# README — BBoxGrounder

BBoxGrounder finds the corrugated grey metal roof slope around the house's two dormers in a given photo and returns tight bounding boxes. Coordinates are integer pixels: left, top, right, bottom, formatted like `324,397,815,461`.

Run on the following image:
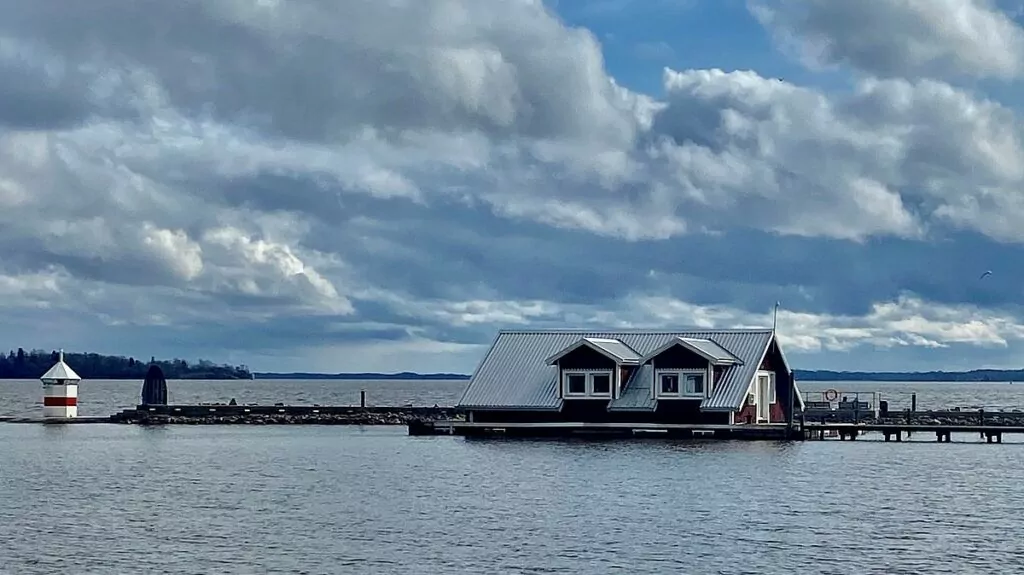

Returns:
459,329,771,409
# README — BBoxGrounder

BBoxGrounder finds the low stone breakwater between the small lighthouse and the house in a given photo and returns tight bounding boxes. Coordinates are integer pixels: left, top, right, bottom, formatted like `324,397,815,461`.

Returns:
111,405,462,426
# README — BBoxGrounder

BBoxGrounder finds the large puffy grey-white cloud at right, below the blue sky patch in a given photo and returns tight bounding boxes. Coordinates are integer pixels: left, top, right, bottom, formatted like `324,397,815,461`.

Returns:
655,70,1024,241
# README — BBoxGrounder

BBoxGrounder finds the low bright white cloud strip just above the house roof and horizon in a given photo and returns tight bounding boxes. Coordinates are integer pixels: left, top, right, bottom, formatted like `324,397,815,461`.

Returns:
342,293,1024,368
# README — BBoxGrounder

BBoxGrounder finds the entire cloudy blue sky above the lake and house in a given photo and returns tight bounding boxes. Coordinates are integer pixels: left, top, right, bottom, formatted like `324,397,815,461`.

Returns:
6,0,1024,371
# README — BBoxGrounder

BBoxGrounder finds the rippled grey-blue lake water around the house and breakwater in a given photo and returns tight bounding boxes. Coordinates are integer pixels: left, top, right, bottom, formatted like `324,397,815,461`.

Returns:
0,380,1024,575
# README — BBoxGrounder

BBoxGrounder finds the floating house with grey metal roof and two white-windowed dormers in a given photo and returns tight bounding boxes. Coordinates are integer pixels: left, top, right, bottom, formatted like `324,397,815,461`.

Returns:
458,329,803,426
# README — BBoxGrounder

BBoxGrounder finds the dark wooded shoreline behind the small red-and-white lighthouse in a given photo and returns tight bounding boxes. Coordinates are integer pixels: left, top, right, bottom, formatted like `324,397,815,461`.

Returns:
0,348,252,380
